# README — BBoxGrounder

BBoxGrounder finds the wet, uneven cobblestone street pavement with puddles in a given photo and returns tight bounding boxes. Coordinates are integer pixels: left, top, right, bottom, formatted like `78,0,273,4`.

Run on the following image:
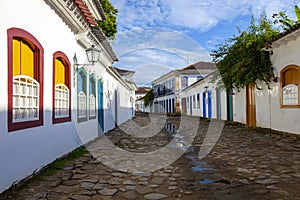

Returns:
0,114,300,200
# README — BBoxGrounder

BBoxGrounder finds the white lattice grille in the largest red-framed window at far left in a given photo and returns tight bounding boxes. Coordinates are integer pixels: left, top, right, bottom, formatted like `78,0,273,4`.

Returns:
12,75,40,122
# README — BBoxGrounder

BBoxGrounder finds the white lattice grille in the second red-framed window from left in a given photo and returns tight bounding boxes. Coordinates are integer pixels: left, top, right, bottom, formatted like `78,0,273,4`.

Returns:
54,84,69,118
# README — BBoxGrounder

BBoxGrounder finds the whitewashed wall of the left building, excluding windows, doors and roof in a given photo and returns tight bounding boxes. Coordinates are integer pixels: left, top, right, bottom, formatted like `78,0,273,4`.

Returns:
0,0,131,192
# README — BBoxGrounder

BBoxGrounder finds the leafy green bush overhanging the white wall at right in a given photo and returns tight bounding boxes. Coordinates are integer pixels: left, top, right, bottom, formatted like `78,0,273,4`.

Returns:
211,14,279,89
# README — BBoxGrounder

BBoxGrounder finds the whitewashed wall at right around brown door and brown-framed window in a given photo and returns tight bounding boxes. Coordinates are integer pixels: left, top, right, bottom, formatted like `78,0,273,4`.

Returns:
234,38,300,134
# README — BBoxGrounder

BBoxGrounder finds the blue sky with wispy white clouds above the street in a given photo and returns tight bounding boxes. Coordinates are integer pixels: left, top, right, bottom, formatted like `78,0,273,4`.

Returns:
110,0,299,85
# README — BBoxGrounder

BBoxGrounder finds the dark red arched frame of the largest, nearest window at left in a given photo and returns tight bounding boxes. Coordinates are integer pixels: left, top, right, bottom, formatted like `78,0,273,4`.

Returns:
7,28,44,131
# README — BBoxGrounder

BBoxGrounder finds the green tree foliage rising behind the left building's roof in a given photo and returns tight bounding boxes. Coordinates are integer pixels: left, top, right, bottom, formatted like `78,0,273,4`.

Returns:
98,0,118,39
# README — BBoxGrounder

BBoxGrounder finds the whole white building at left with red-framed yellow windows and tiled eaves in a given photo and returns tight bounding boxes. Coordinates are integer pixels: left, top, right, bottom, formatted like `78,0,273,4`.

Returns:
0,0,133,192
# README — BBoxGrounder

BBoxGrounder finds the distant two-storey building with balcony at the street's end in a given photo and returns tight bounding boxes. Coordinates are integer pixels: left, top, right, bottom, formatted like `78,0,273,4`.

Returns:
152,62,216,113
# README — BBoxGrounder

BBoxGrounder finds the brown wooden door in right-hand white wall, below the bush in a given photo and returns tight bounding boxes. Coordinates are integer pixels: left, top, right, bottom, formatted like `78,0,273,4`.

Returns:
246,84,256,126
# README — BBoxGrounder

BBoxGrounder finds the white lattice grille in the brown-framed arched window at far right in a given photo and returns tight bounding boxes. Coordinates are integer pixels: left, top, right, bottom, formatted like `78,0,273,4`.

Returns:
282,84,298,105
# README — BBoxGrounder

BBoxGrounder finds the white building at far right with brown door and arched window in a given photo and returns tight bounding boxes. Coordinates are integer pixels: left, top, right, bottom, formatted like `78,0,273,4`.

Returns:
234,25,300,134
